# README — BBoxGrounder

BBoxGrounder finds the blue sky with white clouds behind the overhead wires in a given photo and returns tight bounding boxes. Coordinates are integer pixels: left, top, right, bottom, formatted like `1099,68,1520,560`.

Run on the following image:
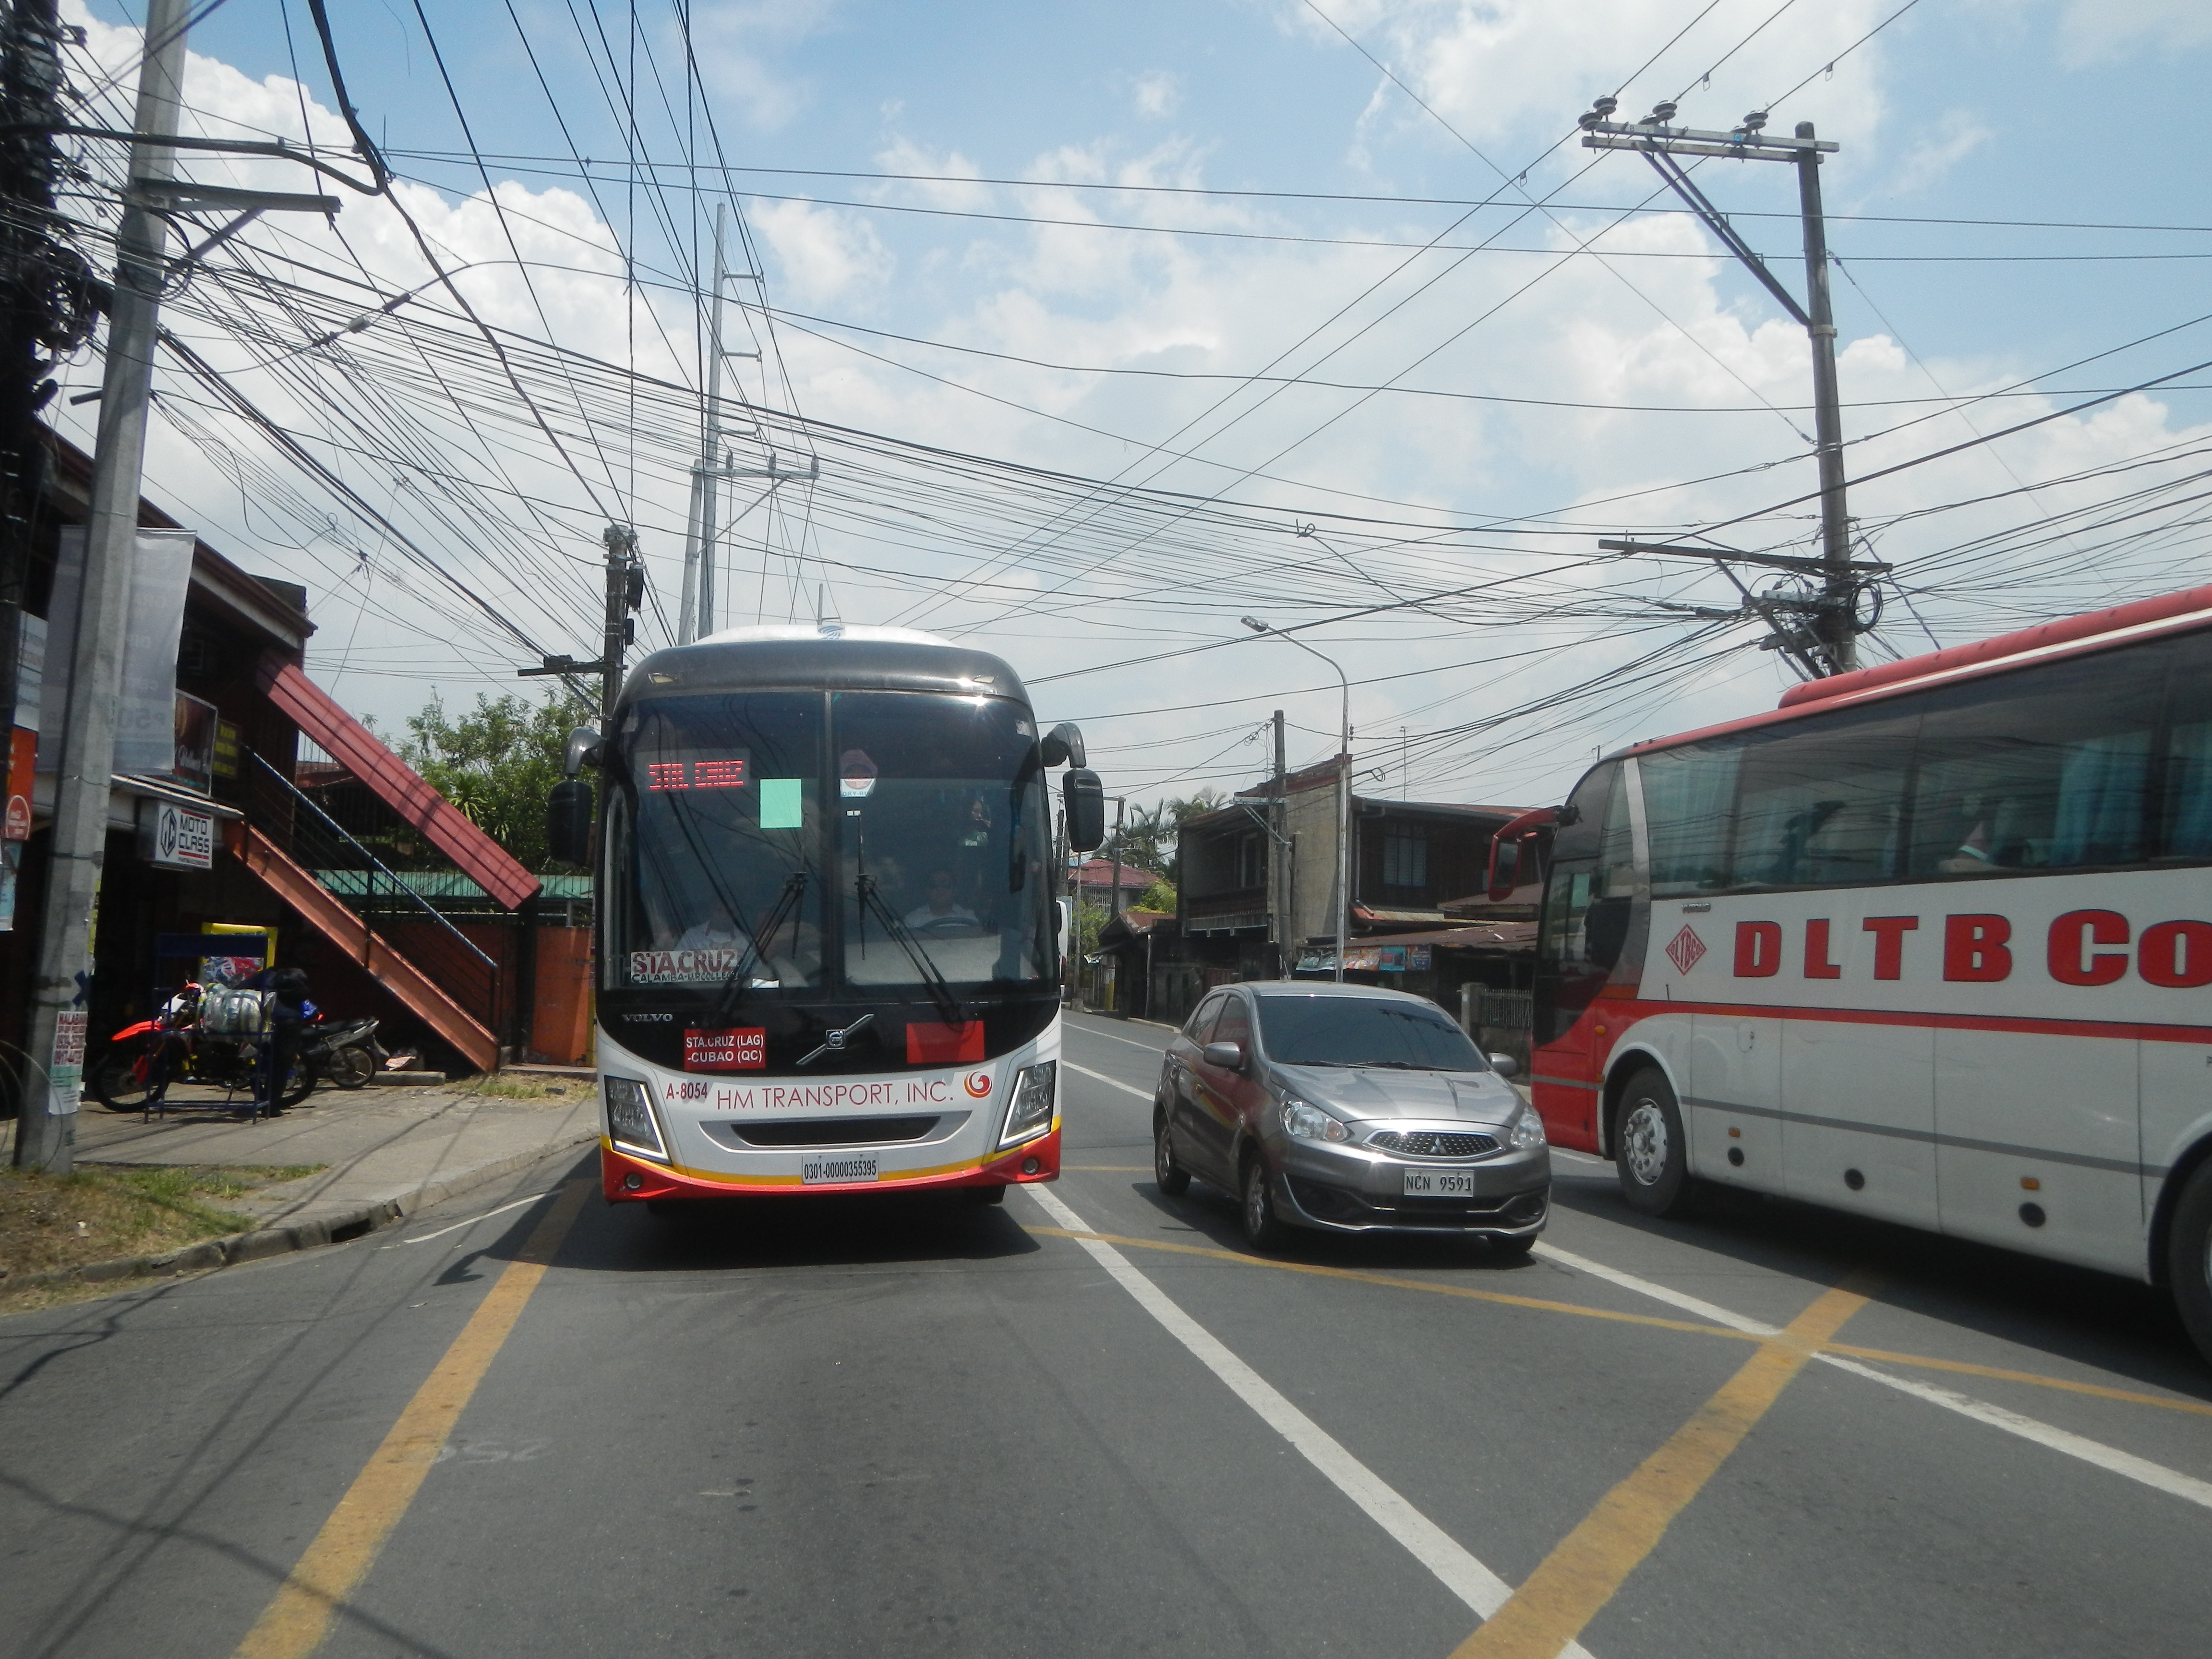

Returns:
60,0,2212,798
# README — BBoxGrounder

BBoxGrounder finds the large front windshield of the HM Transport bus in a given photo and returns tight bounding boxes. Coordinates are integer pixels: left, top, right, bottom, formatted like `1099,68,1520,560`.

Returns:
606,692,1053,1000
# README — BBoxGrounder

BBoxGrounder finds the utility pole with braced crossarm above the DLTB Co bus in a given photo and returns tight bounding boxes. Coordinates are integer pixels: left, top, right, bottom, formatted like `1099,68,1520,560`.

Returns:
1582,97,1858,674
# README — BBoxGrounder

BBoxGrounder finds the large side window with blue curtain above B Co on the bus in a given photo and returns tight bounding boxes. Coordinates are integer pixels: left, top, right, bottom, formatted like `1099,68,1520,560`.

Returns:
1907,652,2164,876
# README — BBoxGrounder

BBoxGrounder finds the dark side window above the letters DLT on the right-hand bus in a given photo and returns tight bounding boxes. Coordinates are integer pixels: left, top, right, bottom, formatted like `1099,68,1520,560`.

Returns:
1732,710,1920,887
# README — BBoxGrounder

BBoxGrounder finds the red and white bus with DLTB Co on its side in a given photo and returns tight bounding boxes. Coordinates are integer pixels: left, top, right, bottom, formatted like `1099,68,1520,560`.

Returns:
1493,586,2212,1358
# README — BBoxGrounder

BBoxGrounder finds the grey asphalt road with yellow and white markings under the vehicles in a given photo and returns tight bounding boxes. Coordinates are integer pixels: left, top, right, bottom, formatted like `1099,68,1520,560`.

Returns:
0,1018,2212,1659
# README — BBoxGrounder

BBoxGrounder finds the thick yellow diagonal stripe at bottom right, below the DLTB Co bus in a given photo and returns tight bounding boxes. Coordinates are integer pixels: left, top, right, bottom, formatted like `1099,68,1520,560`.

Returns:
1451,1285,1867,1659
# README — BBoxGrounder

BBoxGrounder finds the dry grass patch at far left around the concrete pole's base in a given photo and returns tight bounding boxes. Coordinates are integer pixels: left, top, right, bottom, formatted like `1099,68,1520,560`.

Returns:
0,1164,325,1289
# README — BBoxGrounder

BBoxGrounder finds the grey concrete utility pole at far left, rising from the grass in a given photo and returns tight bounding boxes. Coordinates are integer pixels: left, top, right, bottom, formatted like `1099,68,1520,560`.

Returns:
15,0,190,1175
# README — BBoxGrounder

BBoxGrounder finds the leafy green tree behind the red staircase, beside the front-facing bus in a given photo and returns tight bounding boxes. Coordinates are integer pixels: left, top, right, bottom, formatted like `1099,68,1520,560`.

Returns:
394,692,595,874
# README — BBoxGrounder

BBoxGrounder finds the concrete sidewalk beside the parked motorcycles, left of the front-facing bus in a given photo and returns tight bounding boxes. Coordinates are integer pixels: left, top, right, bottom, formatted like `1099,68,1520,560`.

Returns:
77,1077,600,1254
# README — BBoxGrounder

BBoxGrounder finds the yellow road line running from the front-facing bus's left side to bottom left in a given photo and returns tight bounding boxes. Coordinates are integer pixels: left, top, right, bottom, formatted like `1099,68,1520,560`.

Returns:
237,1179,597,1659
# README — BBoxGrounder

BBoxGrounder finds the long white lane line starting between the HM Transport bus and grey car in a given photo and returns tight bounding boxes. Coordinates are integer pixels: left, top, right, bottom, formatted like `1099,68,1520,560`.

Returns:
1022,1186,1588,1659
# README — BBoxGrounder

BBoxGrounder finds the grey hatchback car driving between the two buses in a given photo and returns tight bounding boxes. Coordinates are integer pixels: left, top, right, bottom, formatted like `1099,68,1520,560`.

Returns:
1153,980,1551,1254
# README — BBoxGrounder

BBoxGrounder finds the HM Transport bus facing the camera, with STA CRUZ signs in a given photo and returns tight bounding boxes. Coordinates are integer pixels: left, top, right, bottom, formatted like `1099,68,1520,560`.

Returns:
551,624,1104,1210
